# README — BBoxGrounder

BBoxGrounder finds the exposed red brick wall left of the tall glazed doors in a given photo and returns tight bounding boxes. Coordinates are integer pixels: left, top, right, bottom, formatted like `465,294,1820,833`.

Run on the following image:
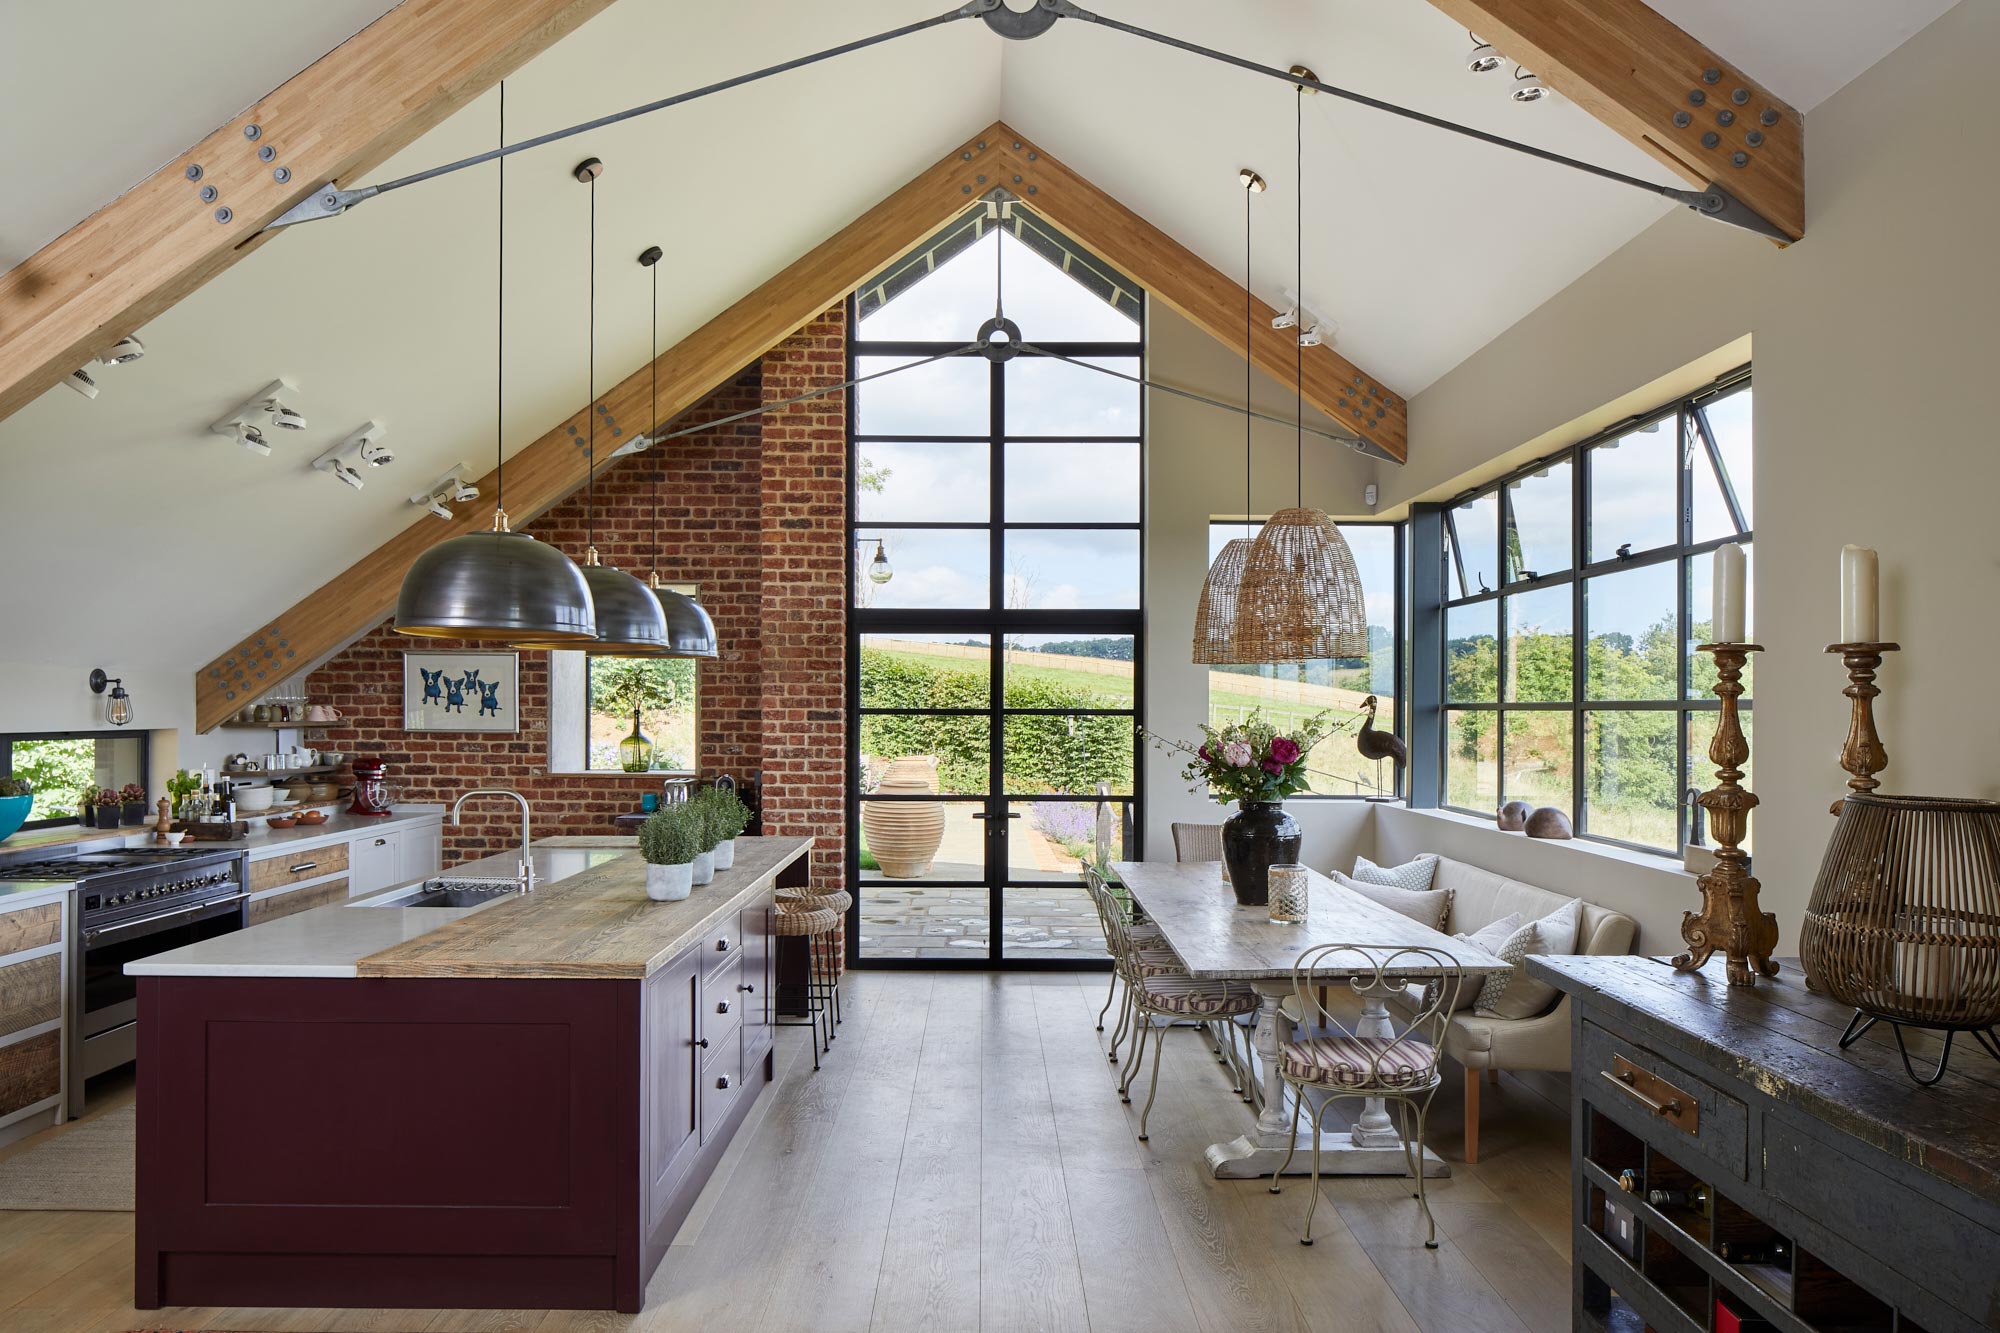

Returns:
308,308,846,872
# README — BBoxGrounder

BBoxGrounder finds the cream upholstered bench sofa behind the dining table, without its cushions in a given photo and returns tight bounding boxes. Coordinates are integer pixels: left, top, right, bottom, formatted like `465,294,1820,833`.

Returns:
1390,857,1638,1161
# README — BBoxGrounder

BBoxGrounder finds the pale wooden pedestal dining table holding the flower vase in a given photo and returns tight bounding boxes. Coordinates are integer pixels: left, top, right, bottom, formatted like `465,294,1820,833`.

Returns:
1114,861,1508,1179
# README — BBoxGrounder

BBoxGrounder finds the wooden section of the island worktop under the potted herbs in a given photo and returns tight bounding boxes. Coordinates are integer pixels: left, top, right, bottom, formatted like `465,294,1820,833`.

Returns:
348,837,812,979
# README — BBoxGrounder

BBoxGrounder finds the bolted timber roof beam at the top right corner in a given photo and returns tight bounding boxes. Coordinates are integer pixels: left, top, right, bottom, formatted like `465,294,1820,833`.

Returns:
1430,0,1806,240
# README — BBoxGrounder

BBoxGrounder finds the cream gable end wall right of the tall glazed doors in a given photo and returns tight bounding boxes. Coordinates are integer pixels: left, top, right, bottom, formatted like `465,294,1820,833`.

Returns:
1146,302,1372,869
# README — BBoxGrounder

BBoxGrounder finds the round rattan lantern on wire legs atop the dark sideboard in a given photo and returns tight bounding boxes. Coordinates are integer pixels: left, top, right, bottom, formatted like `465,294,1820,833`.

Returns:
1798,793,2000,1085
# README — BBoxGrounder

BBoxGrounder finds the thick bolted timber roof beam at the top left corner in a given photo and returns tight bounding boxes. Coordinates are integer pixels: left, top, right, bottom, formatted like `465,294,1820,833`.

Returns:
0,0,610,420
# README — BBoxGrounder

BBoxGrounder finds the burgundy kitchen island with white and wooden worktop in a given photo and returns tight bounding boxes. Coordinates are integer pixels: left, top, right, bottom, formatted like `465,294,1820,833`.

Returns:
132,839,812,1311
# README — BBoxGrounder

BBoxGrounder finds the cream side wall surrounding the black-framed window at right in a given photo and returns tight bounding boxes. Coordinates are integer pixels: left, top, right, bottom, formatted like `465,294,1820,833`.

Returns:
1360,4,2000,932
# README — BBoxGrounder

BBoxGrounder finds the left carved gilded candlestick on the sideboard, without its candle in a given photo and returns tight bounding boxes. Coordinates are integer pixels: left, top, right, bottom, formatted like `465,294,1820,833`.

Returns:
1674,642,1778,987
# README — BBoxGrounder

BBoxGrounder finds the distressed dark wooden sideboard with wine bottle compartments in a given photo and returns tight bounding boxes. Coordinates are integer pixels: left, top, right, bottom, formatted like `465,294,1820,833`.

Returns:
1530,957,2000,1333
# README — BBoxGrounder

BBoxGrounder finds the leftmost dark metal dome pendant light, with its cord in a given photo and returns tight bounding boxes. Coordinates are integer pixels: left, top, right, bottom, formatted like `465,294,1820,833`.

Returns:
396,82,598,644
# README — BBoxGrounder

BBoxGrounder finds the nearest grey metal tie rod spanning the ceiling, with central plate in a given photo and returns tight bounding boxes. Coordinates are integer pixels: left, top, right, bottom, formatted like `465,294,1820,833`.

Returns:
266,0,1792,244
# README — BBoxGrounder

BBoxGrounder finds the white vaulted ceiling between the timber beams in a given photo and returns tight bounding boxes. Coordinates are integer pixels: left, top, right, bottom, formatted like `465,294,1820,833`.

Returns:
0,0,1950,684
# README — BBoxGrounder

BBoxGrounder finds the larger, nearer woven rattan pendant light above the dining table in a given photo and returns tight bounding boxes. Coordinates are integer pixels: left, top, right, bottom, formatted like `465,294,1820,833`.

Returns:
1232,72,1368,662
